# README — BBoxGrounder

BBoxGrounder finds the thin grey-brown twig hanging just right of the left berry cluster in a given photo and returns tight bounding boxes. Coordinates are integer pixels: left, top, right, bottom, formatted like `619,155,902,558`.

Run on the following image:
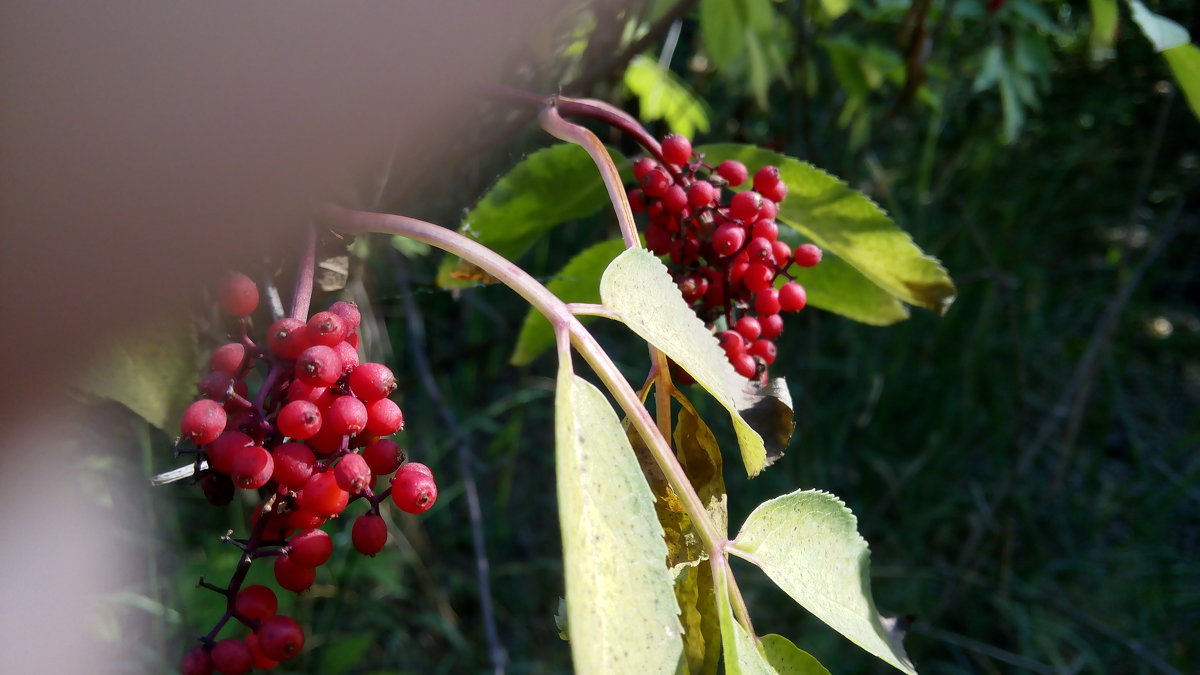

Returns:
388,246,509,675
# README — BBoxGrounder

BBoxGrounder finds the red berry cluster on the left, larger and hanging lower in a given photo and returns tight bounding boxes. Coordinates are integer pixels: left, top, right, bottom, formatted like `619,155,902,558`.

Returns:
180,274,438,675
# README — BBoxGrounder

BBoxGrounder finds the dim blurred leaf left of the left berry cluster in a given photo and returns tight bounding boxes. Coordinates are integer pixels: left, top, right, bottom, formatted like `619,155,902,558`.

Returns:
79,321,197,434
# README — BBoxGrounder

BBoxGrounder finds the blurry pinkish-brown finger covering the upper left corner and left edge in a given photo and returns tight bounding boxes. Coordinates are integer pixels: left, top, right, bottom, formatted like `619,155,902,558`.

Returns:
0,0,562,674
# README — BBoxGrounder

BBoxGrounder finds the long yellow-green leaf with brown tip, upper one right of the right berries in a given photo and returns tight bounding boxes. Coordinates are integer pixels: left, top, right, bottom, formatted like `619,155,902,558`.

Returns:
697,144,955,313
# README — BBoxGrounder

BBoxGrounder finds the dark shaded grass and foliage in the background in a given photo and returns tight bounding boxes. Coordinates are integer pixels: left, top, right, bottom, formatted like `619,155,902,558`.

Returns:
96,0,1200,674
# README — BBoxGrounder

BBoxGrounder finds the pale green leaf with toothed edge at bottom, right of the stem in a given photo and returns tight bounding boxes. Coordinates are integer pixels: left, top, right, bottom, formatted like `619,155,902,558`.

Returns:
731,490,917,674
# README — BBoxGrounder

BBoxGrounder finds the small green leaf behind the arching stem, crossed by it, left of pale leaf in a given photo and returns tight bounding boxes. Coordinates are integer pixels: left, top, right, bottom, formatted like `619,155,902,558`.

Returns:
509,239,625,365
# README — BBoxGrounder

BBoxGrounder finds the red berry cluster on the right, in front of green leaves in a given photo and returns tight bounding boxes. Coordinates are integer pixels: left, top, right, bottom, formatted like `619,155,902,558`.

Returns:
629,133,821,378
